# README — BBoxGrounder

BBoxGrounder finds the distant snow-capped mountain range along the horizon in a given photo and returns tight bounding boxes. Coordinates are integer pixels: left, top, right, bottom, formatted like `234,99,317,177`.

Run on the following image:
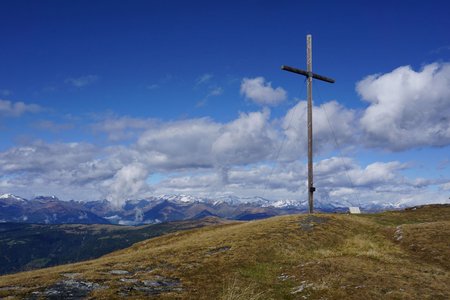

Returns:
0,194,426,225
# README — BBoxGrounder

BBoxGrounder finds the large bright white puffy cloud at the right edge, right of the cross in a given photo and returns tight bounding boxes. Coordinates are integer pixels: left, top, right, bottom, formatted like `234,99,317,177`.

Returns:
356,63,450,151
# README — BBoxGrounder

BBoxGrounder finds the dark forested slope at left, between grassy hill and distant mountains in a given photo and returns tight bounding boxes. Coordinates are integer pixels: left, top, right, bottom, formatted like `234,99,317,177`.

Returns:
0,218,224,275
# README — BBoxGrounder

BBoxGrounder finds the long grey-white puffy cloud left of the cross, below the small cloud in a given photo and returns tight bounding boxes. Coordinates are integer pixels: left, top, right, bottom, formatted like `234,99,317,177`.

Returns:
137,110,277,170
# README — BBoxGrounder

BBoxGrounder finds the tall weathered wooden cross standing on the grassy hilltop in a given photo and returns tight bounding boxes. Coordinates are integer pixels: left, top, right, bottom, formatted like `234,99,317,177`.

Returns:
281,34,334,214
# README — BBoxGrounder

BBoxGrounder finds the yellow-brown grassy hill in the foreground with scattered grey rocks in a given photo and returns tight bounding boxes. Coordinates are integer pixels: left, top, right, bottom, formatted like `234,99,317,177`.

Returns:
0,206,450,299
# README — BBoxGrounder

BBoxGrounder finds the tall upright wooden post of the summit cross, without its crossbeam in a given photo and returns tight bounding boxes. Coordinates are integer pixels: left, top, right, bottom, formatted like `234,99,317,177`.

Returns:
306,34,315,214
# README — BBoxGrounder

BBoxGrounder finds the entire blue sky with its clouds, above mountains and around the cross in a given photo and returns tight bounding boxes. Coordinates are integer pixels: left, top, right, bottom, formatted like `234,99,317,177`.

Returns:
0,0,450,203
